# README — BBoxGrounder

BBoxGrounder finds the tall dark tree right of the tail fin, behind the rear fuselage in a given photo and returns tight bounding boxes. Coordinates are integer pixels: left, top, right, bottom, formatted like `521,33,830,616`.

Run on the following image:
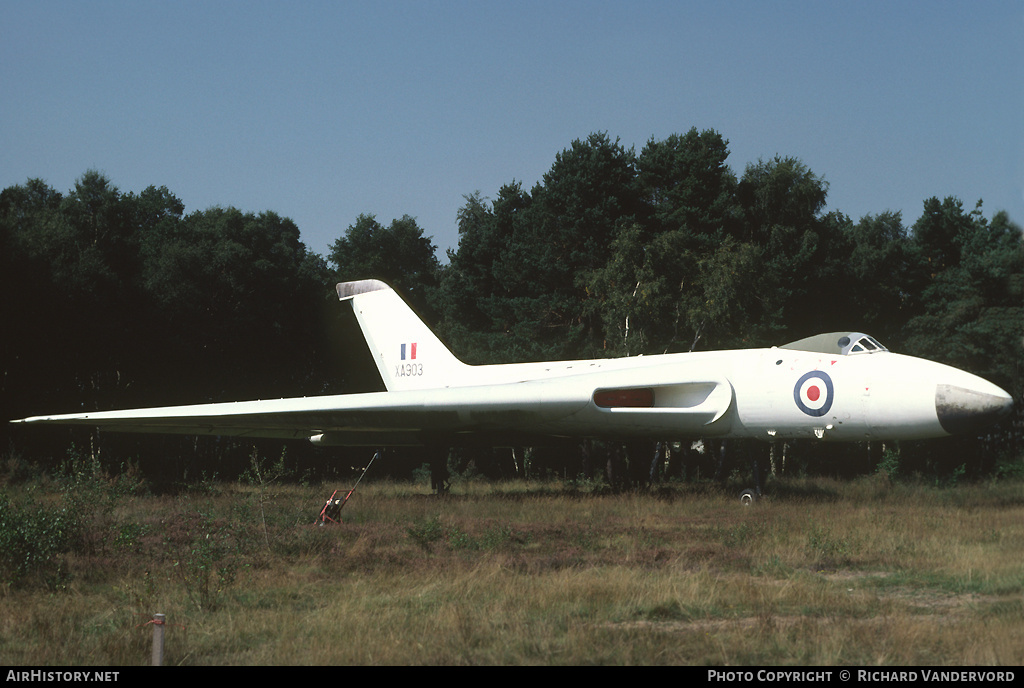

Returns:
445,133,641,360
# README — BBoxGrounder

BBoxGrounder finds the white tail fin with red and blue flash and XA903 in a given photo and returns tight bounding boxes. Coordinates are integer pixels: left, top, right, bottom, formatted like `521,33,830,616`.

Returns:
337,280,470,392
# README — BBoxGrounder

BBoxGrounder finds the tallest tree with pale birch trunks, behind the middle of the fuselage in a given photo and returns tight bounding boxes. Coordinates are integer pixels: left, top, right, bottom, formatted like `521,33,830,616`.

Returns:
588,129,757,354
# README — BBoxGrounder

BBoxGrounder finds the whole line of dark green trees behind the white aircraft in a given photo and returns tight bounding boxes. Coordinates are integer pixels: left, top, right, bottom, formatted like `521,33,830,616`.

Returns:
0,129,1024,483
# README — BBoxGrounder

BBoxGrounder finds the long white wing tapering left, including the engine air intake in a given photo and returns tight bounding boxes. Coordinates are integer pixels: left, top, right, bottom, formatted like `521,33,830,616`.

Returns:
15,375,732,446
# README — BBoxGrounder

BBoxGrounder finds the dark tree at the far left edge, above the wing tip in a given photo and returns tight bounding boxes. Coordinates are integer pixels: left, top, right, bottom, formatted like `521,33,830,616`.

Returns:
3,171,146,419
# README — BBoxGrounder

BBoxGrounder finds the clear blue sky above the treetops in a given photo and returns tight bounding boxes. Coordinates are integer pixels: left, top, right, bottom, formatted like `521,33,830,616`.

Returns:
0,0,1024,258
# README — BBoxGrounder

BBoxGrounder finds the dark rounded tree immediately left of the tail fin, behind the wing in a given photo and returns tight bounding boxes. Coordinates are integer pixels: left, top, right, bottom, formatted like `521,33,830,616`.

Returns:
143,208,330,400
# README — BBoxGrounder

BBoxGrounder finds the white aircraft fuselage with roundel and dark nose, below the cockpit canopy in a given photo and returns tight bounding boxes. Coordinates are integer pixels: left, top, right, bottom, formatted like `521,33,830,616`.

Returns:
374,348,1012,441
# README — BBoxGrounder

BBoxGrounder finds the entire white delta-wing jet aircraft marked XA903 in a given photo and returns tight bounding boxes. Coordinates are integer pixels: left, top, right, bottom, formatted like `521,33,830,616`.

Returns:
13,280,1013,447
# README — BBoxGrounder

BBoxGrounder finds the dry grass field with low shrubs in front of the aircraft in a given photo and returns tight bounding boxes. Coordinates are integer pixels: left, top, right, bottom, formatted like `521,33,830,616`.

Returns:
0,462,1024,667
